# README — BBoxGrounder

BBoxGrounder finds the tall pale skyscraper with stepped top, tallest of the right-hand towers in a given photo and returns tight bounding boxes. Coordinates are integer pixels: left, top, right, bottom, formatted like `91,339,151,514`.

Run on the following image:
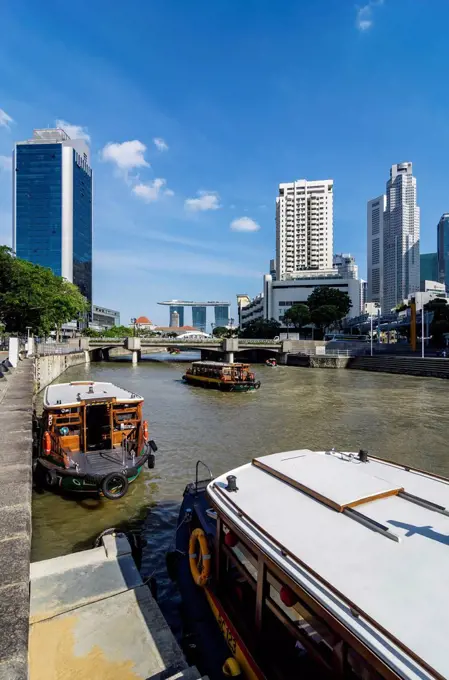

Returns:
382,163,420,312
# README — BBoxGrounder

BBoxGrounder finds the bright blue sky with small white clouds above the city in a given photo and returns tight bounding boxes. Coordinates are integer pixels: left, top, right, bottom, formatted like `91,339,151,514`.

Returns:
0,0,449,323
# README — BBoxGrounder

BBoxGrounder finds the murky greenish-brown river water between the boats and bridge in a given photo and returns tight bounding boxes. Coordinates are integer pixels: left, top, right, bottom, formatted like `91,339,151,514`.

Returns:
32,355,449,608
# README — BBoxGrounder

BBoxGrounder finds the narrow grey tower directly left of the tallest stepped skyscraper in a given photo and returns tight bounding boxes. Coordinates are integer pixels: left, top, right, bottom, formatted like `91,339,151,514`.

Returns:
365,194,387,307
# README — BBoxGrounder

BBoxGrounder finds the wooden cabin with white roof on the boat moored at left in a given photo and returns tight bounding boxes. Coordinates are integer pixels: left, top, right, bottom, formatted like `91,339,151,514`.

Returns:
42,381,143,453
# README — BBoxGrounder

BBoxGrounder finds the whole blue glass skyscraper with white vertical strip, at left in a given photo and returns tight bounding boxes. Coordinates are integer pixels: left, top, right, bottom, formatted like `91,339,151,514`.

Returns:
13,129,92,302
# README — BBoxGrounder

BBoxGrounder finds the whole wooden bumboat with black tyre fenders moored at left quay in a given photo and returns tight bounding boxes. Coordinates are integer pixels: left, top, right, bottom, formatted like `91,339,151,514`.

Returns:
35,381,157,500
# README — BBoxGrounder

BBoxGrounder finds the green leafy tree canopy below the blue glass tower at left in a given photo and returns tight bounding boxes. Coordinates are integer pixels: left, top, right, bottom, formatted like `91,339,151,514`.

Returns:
0,246,88,335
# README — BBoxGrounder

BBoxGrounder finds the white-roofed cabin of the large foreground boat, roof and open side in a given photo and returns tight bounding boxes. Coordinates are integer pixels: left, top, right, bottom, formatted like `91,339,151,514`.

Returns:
205,450,449,680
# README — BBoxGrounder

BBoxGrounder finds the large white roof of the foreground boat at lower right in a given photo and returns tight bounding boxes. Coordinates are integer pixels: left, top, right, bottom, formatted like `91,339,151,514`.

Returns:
208,449,449,680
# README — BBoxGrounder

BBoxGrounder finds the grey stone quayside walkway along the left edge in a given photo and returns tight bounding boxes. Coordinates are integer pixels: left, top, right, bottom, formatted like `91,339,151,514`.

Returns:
0,360,33,680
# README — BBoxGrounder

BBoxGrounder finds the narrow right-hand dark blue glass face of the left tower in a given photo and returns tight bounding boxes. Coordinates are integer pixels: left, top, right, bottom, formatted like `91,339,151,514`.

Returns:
73,151,92,302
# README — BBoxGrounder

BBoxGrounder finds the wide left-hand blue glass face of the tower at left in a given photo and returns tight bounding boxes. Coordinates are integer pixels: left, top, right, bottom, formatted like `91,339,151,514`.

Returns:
15,144,62,276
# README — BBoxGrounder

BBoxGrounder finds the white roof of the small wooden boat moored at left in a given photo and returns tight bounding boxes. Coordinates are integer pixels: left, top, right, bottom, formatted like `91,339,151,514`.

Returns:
44,380,143,408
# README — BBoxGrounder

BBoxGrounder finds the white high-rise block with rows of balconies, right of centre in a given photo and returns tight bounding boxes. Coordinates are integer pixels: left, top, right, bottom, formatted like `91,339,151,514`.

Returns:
276,179,334,281
